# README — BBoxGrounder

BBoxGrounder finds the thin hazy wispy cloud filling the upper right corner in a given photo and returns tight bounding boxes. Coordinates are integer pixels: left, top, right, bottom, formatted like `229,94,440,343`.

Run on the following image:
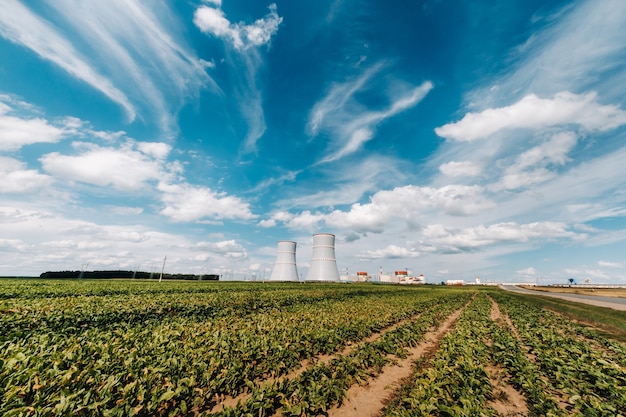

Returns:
468,0,626,108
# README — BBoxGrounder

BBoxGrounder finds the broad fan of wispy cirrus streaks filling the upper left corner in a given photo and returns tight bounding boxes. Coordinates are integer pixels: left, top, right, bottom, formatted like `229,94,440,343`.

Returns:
0,0,212,135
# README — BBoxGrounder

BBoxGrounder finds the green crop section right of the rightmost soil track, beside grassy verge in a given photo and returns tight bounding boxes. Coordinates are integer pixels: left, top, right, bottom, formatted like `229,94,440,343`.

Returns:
494,294,626,416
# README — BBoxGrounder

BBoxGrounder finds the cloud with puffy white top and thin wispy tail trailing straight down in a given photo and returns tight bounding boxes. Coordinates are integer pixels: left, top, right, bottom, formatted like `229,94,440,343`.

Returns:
193,1,283,153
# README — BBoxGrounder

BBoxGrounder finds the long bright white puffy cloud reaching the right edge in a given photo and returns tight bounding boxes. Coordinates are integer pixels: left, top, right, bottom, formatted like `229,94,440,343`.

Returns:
435,91,626,141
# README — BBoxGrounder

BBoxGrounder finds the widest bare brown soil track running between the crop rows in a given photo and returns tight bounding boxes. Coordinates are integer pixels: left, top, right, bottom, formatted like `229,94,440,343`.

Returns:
328,302,463,417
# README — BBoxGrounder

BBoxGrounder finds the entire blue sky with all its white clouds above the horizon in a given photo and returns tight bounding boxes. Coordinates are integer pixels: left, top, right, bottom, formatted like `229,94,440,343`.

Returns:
0,0,626,284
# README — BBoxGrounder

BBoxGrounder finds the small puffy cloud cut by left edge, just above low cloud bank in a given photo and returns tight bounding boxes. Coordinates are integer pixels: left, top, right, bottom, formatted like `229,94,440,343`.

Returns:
0,156,52,194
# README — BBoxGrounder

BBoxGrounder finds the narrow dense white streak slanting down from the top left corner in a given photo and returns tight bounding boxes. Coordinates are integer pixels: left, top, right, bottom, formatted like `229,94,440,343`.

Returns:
0,0,135,120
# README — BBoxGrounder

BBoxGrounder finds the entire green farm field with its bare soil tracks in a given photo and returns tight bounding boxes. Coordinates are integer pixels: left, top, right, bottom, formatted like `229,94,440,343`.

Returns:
0,280,626,417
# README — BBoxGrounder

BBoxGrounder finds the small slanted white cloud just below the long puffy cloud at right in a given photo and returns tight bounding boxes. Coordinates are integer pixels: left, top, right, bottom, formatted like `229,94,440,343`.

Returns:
489,132,578,191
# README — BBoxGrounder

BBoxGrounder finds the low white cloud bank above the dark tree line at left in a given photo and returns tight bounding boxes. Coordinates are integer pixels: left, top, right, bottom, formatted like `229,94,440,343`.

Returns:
0,205,254,275
